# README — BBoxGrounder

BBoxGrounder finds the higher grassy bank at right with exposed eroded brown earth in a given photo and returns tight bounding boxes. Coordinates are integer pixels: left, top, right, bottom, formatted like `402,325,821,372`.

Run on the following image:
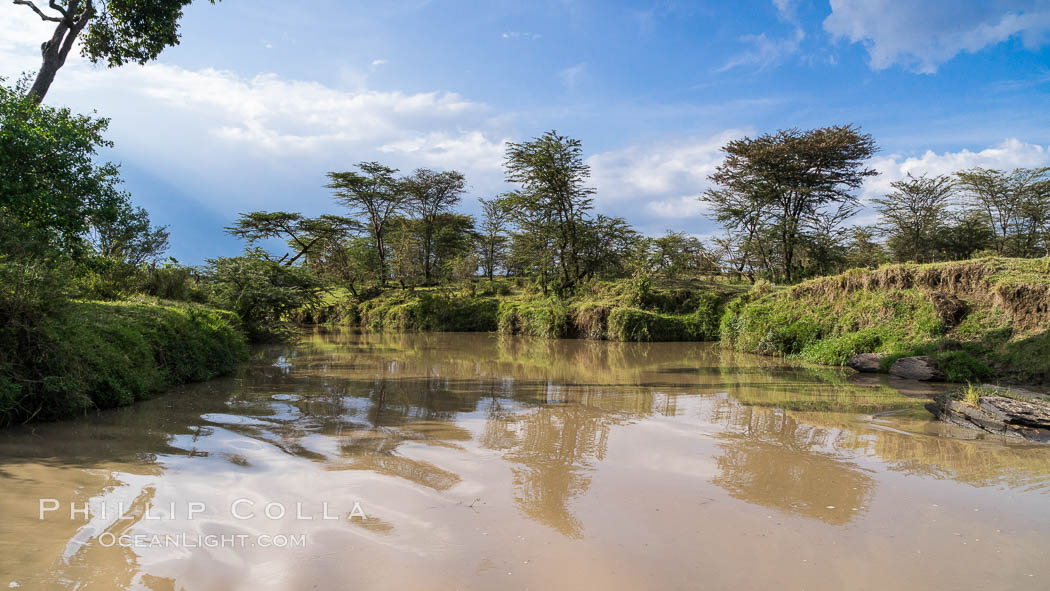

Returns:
720,258,1050,383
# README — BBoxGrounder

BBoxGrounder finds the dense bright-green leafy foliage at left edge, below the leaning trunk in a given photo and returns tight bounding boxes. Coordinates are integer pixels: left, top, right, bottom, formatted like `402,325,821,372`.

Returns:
0,84,167,263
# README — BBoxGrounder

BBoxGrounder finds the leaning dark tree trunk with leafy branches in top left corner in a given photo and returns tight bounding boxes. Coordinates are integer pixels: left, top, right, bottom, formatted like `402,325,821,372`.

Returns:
13,0,217,104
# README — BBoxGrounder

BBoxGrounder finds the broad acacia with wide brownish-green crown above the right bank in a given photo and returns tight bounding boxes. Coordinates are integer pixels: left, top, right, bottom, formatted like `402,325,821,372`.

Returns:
700,125,878,281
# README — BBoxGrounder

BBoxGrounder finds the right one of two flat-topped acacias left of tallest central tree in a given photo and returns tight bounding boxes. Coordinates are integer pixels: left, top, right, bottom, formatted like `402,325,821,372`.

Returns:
401,168,466,286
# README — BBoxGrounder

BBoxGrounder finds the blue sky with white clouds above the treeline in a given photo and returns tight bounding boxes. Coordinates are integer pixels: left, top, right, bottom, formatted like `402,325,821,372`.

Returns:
0,0,1050,263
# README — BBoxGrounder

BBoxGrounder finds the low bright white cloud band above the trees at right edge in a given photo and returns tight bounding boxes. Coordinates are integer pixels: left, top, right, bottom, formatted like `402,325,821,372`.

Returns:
861,138,1050,200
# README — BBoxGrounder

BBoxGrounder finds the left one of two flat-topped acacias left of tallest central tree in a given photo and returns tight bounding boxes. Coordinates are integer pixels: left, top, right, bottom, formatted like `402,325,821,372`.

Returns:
328,162,405,286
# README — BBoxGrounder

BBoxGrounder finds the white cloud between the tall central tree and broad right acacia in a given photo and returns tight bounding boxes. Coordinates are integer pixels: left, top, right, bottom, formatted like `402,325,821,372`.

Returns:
587,129,747,220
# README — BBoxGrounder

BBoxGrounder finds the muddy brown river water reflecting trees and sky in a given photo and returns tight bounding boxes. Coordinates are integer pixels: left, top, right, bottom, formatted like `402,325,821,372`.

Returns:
0,332,1050,591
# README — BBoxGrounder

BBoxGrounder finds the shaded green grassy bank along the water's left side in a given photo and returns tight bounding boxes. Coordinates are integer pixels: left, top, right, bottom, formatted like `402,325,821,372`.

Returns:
0,299,248,426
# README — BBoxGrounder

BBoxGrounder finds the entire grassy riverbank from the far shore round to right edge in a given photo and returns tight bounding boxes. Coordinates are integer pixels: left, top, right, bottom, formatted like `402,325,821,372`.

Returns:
306,258,1050,383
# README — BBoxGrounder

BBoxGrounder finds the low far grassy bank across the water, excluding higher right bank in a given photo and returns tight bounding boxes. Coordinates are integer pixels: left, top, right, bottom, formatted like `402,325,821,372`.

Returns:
317,280,747,341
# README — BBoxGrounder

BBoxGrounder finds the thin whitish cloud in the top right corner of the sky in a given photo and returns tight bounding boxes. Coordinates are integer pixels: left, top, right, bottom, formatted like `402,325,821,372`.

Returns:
824,0,1050,73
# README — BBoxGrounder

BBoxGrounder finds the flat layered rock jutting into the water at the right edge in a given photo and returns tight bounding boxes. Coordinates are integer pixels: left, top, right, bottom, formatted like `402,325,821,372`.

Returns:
926,394,1050,443
